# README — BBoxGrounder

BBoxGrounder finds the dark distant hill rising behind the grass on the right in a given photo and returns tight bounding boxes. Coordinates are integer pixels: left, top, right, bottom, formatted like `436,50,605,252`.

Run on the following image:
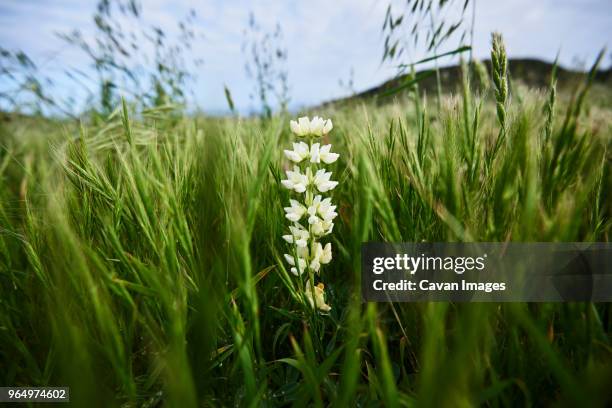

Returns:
324,58,612,105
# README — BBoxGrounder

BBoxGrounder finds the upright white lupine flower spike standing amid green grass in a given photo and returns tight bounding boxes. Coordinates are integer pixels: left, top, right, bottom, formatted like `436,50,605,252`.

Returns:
281,116,339,313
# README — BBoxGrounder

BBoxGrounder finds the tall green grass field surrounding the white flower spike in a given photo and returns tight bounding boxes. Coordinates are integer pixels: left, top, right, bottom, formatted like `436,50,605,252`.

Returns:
0,52,612,407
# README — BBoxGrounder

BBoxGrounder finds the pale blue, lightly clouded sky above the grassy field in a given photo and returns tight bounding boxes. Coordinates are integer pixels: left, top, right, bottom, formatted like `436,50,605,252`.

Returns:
0,0,612,113
